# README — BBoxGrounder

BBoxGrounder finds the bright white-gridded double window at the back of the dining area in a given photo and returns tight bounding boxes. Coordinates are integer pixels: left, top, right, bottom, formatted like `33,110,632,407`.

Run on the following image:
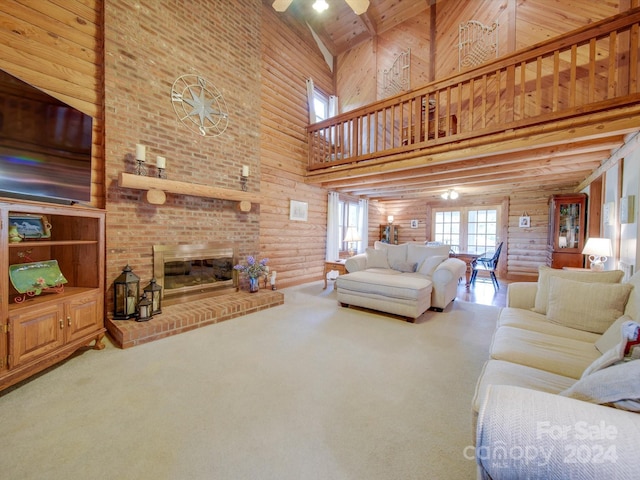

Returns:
432,207,500,253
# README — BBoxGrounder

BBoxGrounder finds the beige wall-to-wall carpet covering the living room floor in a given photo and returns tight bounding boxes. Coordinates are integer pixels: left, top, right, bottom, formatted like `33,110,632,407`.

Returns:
0,282,498,480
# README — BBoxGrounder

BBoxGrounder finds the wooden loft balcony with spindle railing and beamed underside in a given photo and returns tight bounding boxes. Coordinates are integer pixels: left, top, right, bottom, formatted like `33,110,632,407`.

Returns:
307,8,640,200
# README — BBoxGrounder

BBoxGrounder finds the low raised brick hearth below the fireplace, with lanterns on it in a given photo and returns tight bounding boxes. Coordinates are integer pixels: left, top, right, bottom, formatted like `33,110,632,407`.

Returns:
106,290,284,348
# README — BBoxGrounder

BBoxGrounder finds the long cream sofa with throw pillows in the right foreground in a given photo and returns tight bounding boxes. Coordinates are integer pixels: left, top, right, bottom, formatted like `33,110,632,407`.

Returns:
473,267,640,480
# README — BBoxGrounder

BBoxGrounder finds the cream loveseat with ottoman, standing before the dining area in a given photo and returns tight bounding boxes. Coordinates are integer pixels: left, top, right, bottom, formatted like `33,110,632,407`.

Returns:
336,242,467,320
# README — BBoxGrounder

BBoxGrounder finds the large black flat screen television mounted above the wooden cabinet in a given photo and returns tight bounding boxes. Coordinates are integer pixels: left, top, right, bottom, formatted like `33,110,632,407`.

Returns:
0,70,92,204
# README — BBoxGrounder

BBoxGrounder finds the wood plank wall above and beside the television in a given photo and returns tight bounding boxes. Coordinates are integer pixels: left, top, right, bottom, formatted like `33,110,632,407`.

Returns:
0,0,105,207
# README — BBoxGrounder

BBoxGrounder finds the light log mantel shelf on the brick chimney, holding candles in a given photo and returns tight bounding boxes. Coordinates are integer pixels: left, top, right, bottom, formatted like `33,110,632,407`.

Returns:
118,172,260,212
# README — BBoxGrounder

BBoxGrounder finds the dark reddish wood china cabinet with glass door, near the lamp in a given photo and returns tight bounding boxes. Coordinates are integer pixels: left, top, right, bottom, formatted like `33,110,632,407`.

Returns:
548,193,587,268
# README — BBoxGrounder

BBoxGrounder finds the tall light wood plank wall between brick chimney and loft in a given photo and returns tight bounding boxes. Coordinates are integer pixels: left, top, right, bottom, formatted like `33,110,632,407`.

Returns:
260,5,334,286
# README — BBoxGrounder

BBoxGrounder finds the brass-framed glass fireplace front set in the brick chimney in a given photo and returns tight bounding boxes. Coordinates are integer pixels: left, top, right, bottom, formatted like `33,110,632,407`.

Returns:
153,244,237,299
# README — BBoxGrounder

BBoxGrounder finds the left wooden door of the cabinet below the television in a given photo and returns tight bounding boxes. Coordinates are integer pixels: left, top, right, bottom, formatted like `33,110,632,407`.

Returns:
9,303,65,368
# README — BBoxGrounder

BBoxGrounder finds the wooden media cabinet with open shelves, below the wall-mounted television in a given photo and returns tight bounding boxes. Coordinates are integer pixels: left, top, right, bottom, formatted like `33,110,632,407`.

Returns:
0,199,105,390
